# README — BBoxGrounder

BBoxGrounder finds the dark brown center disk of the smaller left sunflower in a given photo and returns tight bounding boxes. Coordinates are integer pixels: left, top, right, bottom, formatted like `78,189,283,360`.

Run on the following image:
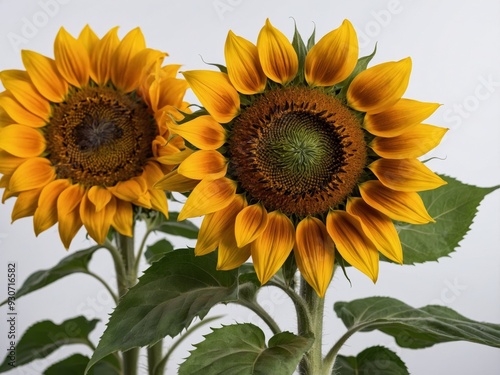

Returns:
45,87,157,187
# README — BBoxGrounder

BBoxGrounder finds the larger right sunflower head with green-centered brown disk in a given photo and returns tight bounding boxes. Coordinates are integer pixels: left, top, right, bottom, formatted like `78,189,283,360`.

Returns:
157,20,446,297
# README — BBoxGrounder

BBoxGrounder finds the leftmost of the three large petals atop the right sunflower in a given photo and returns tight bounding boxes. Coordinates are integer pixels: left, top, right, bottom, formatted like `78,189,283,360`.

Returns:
224,31,267,95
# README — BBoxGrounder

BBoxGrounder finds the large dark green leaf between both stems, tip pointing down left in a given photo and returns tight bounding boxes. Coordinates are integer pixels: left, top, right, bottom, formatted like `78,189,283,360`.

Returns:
87,249,238,370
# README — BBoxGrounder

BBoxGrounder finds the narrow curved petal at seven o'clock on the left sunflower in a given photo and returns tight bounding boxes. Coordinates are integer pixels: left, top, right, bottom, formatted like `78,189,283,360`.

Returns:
33,179,71,236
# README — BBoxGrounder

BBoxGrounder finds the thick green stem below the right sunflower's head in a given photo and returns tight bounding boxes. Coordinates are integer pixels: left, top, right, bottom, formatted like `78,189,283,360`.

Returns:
297,277,325,375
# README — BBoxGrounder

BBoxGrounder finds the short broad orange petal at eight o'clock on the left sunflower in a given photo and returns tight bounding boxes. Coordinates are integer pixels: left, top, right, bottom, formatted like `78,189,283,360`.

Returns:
9,158,56,193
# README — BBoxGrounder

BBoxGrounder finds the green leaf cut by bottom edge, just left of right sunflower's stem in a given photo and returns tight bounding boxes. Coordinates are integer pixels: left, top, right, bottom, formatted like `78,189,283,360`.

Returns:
179,323,313,375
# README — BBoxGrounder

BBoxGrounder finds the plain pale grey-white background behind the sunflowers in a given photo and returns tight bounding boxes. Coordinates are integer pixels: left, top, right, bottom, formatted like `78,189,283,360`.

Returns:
0,0,500,375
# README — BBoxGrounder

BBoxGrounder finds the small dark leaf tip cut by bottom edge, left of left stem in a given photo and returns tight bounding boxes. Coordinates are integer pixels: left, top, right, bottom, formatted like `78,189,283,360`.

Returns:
43,354,121,375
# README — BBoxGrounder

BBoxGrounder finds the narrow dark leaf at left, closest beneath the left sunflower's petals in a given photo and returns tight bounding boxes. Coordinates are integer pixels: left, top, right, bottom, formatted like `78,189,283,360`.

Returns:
0,245,102,306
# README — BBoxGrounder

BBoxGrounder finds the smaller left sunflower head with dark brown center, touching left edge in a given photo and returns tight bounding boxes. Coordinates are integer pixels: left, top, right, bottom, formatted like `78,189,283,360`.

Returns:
0,26,187,248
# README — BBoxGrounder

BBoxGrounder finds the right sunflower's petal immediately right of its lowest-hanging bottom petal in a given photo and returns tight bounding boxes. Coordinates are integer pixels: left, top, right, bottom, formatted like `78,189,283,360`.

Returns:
326,211,379,282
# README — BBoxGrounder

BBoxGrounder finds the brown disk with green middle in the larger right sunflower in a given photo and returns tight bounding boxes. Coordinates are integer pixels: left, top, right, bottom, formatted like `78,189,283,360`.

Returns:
230,87,366,217
